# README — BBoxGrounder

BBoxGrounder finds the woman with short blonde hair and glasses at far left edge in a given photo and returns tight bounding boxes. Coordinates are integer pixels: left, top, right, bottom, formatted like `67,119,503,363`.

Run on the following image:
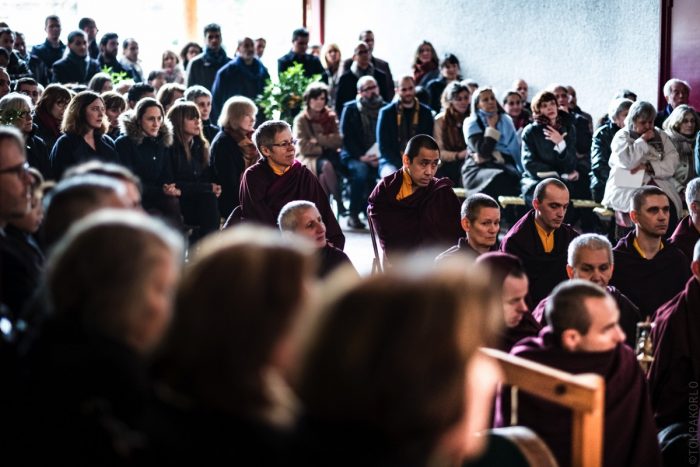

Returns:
0,92,53,179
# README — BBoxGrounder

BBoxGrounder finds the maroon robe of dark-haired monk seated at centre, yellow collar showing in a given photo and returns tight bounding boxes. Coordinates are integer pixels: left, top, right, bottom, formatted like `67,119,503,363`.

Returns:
367,169,464,256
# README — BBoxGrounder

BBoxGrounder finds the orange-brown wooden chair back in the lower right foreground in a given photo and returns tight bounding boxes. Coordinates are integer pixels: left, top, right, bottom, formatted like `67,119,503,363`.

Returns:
481,348,605,467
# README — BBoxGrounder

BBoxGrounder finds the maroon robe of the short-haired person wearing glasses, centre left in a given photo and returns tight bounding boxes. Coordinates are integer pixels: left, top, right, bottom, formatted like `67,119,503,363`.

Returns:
240,157,345,250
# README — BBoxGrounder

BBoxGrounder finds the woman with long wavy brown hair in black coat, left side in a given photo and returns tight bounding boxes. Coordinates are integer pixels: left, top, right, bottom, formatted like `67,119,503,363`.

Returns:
51,91,119,179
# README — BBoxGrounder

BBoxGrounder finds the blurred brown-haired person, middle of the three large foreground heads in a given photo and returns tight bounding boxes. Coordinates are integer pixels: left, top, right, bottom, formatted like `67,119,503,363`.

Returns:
150,227,314,466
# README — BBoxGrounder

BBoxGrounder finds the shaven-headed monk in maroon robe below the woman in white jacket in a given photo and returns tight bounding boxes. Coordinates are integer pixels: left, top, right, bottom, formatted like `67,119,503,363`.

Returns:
610,186,690,318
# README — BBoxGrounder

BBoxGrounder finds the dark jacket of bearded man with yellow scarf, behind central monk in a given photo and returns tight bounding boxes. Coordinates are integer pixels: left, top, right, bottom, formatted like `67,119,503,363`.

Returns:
377,102,434,170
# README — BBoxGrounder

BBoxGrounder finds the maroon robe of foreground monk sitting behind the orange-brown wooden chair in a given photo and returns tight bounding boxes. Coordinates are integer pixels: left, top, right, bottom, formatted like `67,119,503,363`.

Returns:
496,327,661,467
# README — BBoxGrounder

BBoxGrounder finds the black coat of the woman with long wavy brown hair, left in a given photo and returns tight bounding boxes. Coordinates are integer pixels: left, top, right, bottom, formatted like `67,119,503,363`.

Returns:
50,133,119,179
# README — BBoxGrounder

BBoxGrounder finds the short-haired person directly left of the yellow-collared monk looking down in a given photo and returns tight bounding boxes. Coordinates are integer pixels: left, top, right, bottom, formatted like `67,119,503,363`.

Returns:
435,193,501,261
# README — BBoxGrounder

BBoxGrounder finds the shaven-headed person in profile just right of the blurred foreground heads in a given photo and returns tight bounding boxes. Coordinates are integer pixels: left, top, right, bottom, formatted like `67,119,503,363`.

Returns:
476,251,542,352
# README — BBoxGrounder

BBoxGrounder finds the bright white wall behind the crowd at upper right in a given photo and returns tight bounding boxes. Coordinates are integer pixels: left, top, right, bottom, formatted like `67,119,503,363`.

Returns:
325,0,661,118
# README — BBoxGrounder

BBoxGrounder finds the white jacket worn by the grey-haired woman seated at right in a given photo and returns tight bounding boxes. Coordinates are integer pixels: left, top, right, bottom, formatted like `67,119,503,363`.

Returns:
602,128,683,219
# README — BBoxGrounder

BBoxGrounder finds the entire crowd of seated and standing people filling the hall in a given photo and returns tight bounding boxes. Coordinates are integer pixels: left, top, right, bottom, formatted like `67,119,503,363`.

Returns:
0,11,700,466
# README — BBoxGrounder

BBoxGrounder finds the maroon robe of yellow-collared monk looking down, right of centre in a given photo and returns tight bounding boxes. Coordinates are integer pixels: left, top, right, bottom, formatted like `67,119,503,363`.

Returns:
501,209,579,309
